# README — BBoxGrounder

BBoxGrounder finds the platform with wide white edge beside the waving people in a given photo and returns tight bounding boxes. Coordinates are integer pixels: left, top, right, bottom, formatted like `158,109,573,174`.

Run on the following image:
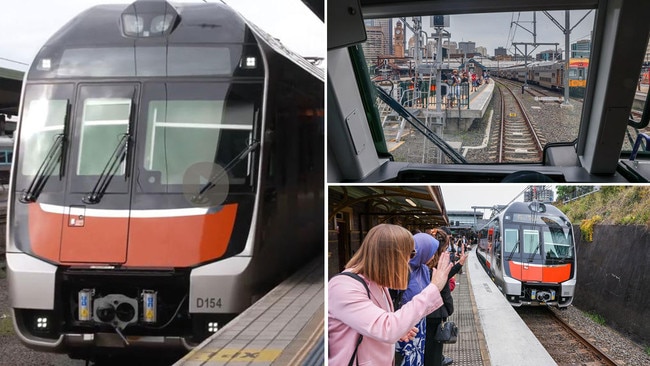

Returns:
443,247,556,366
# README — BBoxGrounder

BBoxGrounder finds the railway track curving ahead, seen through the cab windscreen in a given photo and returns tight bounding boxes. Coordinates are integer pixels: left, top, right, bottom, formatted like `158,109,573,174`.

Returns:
491,81,546,163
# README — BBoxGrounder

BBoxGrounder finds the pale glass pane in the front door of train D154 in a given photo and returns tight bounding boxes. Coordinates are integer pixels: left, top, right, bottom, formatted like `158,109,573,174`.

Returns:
76,98,131,175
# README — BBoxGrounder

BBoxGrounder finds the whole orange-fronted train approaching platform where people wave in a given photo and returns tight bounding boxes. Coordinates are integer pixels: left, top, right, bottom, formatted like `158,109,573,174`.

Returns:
476,201,577,308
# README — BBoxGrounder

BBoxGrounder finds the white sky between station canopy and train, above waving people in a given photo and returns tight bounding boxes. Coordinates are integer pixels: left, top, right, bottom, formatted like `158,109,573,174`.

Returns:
441,183,540,217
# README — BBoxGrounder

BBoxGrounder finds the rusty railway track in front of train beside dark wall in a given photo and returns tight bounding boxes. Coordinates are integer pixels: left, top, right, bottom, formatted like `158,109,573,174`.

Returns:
516,306,616,366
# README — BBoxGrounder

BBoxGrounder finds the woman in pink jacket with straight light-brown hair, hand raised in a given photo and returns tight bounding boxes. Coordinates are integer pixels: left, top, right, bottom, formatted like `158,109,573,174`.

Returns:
328,224,451,366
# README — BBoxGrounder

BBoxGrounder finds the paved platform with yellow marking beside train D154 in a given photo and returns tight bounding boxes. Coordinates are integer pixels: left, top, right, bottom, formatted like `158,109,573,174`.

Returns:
174,257,325,366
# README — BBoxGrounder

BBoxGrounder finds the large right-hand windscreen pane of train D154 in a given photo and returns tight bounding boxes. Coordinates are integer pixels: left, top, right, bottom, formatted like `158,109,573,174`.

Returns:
143,83,261,186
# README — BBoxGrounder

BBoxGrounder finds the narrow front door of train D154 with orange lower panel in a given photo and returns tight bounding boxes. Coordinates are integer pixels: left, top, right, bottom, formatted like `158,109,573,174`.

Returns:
59,84,138,264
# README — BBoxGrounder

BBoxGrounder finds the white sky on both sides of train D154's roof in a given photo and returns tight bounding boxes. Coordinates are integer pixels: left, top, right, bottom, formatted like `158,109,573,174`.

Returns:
0,0,326,71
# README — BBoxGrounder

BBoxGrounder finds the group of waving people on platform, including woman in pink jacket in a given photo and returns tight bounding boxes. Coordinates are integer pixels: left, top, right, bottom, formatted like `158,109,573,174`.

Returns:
328,224,469,366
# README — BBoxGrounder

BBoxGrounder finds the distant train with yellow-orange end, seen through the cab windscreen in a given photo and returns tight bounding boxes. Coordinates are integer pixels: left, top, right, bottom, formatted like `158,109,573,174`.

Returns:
497,58,589,98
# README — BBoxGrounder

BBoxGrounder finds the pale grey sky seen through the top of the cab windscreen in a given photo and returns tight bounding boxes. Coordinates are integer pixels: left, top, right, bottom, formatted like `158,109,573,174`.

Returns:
394,10,595,56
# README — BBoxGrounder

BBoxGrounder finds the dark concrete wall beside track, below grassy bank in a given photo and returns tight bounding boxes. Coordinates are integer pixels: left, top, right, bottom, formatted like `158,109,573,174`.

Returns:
573,225,650,344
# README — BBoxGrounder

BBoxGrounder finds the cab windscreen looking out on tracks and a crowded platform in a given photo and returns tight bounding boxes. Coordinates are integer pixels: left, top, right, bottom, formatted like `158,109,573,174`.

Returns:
357,9,596,164
